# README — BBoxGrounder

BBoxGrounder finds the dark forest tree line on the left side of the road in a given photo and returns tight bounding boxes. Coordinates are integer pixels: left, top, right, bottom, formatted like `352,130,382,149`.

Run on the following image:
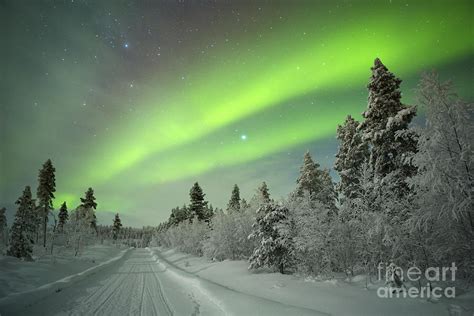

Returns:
0,159,139,260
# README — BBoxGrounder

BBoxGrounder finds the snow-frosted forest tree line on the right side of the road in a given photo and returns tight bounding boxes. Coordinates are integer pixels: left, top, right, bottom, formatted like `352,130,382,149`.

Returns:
153,59,474,280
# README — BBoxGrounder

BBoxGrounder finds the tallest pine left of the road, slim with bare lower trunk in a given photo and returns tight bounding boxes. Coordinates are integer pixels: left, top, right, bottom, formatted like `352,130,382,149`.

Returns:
36,159,56,247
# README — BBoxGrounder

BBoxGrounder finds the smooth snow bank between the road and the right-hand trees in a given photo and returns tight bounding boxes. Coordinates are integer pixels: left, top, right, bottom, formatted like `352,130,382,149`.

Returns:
154,248,473,316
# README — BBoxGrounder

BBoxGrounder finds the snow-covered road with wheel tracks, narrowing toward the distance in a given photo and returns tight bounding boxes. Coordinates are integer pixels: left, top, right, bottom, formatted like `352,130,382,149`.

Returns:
0,249,323,316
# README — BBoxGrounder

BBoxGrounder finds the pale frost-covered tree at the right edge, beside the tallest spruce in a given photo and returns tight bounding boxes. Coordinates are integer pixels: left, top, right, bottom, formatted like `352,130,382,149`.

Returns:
411,73,474,277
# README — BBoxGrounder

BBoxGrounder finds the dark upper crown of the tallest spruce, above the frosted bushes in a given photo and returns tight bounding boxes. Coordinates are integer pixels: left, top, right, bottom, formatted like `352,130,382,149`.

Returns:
360,58,417,185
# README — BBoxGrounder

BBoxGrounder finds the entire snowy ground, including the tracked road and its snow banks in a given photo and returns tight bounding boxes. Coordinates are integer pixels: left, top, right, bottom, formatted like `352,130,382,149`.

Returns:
0,248,472,315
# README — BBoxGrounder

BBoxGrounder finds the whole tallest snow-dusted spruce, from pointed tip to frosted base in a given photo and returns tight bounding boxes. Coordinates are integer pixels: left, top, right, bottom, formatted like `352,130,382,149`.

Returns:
359,58,418,265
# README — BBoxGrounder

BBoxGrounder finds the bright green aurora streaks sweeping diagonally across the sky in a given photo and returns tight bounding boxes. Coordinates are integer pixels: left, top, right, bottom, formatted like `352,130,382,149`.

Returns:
68,0,473,190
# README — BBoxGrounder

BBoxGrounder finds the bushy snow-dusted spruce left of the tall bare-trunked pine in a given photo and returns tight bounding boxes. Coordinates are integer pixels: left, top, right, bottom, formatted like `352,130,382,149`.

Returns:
7,186,36,259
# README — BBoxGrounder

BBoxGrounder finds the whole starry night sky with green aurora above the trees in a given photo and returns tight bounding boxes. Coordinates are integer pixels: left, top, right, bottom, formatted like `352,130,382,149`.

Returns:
0,0,474,226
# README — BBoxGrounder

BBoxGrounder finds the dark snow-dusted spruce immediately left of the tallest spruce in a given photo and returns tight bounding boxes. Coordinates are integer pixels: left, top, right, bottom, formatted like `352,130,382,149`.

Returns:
334,115,369,200
